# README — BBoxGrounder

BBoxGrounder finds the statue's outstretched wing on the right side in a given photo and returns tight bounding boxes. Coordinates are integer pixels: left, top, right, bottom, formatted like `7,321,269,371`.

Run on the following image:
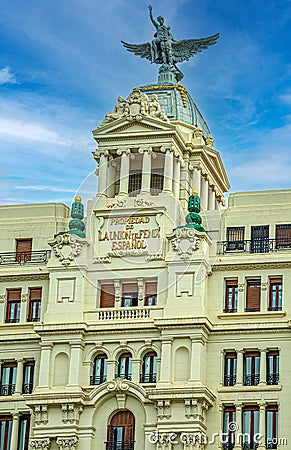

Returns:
172,33,219,63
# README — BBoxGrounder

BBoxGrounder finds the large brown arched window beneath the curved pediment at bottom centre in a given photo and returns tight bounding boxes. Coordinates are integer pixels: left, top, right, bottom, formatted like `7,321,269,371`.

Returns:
106,410,134,450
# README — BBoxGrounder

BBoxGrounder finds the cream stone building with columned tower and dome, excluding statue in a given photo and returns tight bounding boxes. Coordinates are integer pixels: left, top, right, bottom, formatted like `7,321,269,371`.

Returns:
0,84,291,450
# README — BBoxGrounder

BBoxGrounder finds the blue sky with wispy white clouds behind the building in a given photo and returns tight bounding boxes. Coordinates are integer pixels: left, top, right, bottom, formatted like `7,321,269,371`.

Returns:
0,0,291,204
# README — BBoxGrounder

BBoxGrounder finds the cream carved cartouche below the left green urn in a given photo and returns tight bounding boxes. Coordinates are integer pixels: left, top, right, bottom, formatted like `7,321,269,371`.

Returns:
49,233,88,267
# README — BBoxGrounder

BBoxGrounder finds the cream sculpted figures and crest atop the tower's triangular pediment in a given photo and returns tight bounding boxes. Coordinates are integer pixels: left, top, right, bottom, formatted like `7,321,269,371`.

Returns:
99,89,169,127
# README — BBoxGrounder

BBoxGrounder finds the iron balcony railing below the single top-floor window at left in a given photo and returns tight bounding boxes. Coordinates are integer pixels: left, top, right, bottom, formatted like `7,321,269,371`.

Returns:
0,250,51,266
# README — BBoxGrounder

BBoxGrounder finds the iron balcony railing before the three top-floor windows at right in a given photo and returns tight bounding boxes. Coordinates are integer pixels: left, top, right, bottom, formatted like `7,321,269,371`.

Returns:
217,238,291,255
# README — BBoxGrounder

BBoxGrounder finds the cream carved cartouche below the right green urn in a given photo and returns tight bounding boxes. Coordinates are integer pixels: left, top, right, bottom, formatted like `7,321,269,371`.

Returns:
171,227,200,261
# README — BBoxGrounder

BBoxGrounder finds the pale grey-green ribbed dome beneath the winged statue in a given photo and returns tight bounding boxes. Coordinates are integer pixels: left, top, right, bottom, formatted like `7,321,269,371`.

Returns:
137,84,210,136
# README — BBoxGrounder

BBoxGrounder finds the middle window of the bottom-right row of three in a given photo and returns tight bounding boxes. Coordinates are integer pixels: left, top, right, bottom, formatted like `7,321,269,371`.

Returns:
242,406,260,450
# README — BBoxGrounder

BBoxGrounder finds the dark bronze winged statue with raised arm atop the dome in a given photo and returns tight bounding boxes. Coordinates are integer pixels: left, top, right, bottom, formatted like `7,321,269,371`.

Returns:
121,5,219,81
